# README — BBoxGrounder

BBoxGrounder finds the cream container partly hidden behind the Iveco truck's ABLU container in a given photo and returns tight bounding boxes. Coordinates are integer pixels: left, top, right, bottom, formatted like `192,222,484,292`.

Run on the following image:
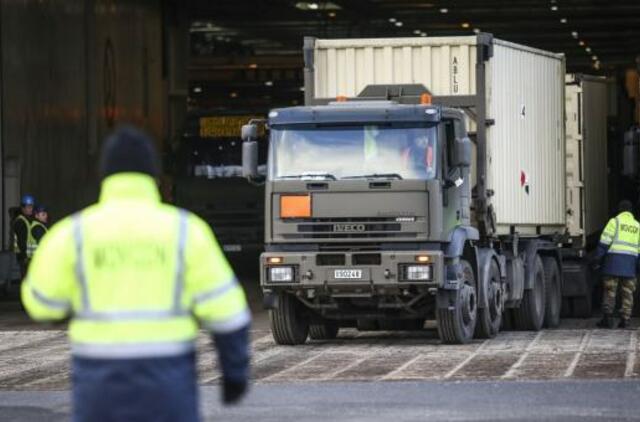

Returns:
566,75,609,242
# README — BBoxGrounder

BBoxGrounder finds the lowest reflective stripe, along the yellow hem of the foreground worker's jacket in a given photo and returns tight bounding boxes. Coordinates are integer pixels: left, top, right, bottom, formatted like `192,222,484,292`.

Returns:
71,341,195,359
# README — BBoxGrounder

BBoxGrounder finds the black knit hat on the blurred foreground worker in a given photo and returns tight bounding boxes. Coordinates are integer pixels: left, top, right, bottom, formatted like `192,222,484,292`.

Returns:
100,126,160,179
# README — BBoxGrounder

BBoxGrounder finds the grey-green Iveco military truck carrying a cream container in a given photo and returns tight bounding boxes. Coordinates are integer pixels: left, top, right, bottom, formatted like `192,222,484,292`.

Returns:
242,33,604,345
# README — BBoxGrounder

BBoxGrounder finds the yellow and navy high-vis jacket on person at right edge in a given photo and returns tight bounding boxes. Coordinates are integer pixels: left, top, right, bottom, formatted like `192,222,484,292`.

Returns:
598,211,640,278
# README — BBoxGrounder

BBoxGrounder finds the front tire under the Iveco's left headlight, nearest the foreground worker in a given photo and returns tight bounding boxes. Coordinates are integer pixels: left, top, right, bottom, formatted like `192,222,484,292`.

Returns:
269,293,309,346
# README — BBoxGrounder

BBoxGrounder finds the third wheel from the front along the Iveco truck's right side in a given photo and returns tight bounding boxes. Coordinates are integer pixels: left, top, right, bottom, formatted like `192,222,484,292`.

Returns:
513,256,545,331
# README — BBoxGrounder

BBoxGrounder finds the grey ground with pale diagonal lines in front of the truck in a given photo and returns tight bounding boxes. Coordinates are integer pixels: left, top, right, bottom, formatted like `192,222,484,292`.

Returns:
0,284,640,422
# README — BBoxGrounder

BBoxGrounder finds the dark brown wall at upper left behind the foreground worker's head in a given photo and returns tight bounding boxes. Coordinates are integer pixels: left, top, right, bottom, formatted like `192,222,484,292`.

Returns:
0,0,165,244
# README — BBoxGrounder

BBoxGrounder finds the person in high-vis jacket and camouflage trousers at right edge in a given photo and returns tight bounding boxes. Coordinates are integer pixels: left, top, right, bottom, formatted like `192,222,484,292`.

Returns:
596,200,640,328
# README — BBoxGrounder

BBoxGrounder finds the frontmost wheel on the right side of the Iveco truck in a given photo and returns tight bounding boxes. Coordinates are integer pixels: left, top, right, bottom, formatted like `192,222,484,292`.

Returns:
436,260,477,344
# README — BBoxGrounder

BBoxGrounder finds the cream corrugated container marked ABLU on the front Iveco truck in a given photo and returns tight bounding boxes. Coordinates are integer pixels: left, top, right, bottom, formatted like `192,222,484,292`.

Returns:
306,34,566,235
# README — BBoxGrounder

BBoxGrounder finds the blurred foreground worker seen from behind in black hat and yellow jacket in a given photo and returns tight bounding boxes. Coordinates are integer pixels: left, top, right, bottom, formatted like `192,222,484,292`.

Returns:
22,128,250,422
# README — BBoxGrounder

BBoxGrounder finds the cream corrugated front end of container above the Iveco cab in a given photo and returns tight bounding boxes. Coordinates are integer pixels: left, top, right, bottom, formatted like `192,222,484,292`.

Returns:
315,37,476,98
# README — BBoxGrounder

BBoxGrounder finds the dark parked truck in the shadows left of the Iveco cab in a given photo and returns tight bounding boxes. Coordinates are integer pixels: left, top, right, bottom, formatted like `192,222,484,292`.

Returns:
171,110,266,273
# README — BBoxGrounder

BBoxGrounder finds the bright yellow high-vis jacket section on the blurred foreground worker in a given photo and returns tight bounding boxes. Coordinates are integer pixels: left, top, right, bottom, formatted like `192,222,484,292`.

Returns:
22,173,250,359
